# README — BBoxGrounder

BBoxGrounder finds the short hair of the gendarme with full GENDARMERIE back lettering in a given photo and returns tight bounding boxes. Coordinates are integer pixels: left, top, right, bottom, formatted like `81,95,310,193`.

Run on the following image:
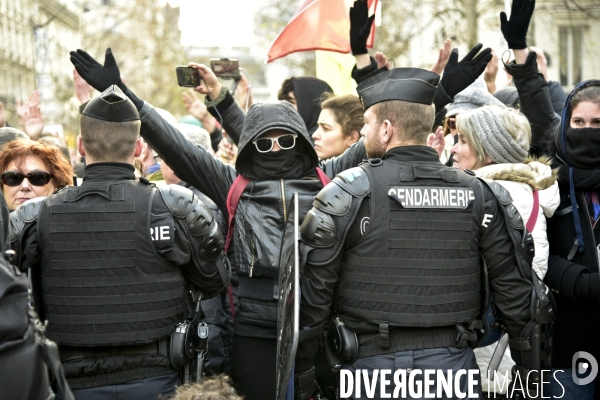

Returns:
373,100,435,144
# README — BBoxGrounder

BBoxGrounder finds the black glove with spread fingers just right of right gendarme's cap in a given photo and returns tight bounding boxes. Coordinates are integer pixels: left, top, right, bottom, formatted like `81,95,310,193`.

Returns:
440,43,492,98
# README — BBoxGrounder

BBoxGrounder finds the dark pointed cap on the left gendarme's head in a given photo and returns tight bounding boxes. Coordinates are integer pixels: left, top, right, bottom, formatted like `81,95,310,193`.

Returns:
81,85,140,122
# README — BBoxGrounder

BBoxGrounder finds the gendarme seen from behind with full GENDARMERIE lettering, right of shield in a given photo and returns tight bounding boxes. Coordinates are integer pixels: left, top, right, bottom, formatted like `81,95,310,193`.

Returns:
296,68,552,399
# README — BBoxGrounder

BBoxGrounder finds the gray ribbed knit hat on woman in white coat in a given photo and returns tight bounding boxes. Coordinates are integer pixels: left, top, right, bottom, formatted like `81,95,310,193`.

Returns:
460,106,528,164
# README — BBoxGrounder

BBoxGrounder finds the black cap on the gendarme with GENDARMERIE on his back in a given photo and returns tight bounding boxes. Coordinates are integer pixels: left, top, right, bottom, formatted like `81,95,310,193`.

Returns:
356,68,440,110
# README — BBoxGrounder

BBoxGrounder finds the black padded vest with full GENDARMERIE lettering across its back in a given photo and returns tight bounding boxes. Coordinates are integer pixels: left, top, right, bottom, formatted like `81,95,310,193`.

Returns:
334,160,484,327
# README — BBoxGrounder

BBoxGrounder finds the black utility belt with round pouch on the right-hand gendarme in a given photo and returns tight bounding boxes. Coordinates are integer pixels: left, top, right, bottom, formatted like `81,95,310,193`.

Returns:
325,317,481,370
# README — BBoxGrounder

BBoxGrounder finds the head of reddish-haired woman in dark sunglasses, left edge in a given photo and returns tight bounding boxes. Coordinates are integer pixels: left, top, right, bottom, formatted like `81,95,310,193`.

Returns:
0,140,73,211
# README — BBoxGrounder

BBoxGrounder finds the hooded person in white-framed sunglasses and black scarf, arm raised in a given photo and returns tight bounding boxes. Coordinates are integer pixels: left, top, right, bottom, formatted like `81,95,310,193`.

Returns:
71,49,340,400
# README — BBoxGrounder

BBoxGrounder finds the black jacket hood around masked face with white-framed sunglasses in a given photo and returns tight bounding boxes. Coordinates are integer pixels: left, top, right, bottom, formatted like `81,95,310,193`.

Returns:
235,101,318,179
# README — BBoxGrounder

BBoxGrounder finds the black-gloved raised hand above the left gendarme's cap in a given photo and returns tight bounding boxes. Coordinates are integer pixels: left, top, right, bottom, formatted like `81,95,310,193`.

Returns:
70,47,125,92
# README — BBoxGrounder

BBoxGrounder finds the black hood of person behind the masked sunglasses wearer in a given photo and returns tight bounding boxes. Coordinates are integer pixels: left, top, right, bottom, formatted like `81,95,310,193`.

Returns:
292,76,333,135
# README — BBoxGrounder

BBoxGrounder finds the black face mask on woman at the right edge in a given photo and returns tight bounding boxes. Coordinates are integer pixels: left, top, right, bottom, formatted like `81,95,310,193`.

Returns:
565,127,600,170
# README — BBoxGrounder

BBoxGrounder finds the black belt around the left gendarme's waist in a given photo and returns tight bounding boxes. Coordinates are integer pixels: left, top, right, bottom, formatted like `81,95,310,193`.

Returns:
60,337,170,363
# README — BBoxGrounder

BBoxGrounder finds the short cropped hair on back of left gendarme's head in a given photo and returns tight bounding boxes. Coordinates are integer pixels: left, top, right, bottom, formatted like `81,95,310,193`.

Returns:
79,115,141,162
